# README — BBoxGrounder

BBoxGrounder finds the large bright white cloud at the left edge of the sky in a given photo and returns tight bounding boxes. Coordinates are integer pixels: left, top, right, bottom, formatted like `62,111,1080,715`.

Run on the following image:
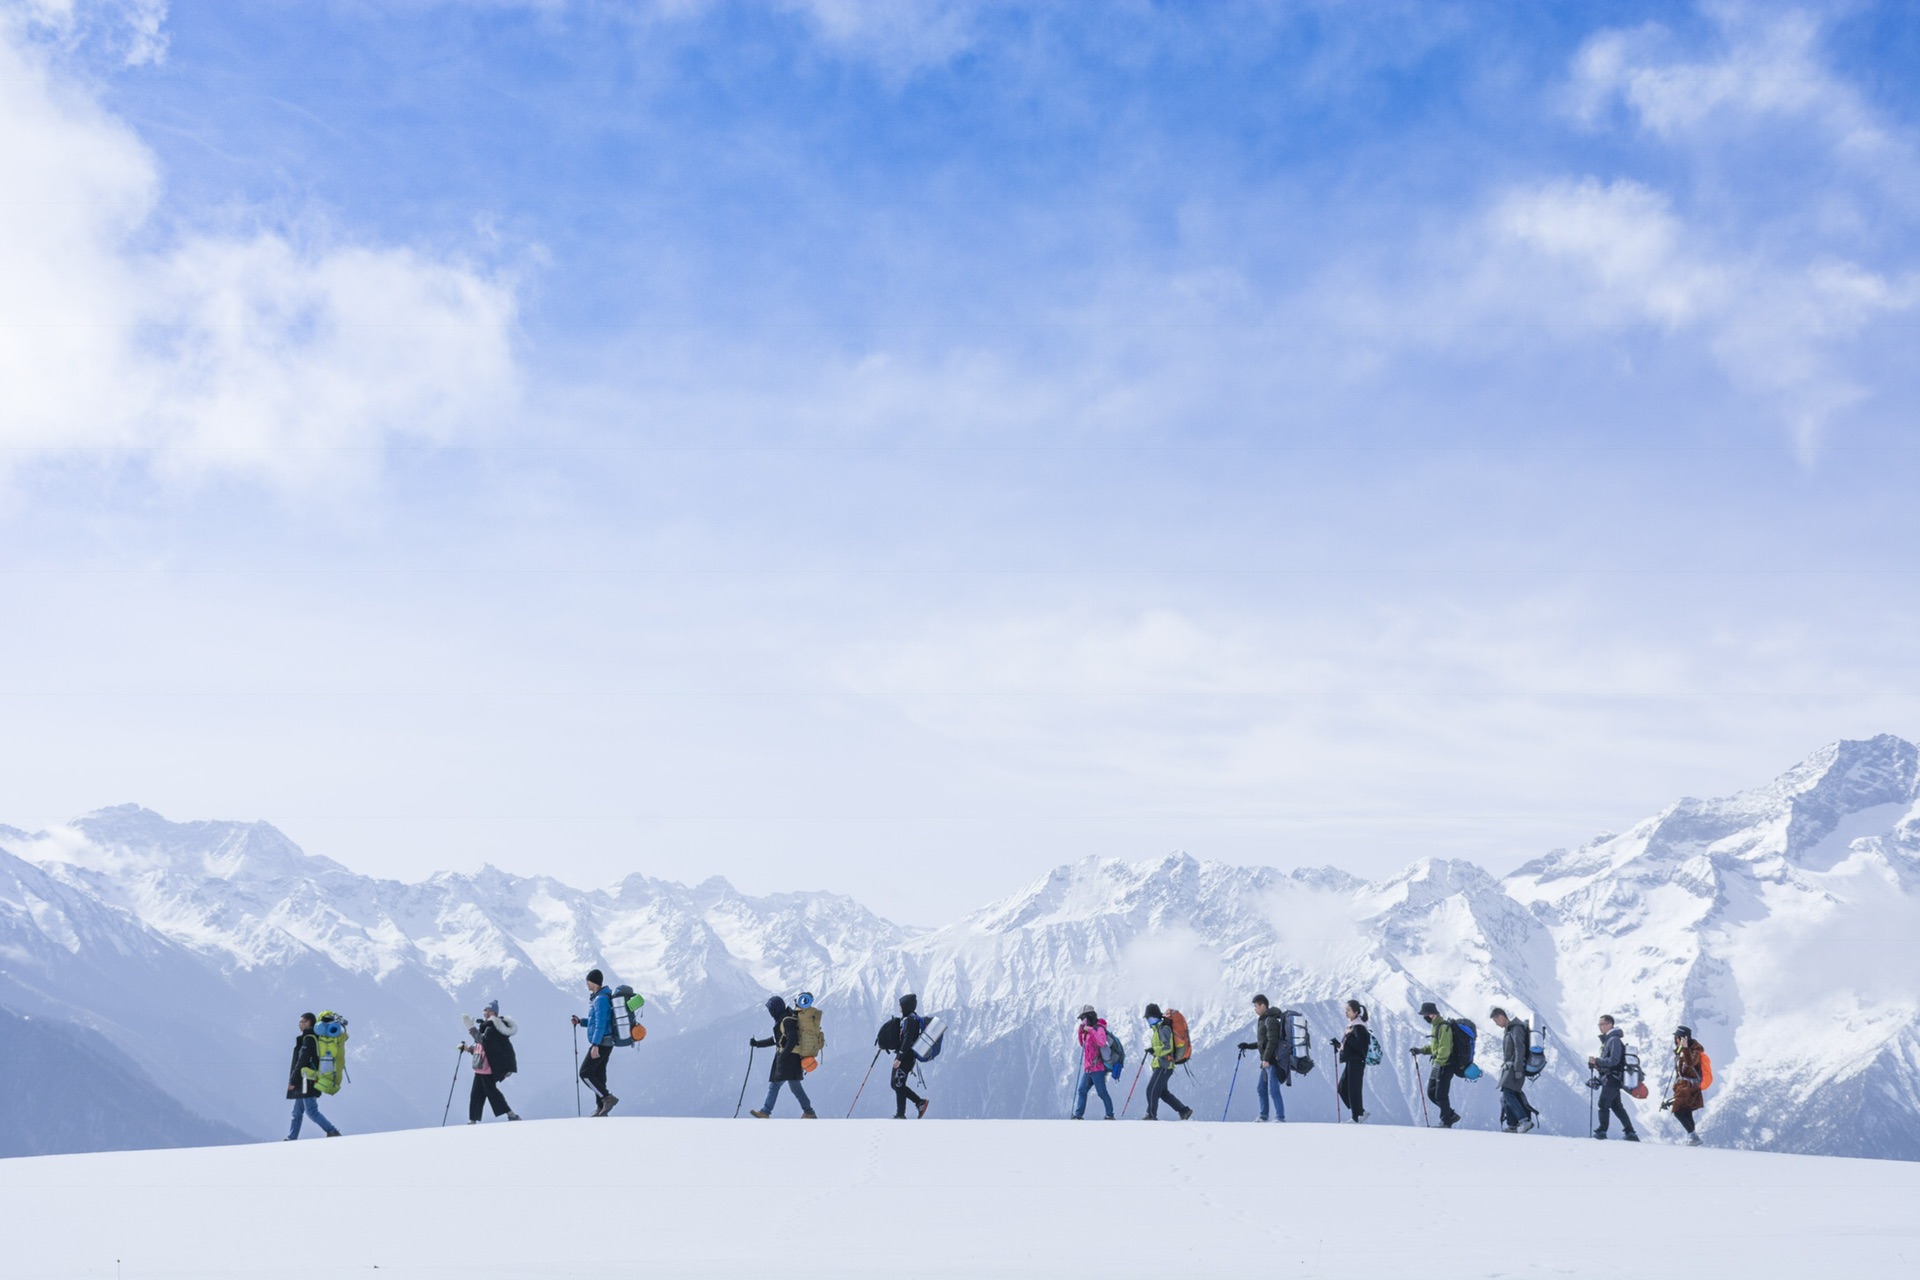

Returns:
0,6,516,486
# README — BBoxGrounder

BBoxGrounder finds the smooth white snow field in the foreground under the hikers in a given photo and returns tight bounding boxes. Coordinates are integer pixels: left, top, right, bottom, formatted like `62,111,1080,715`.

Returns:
0,1103,1920,1280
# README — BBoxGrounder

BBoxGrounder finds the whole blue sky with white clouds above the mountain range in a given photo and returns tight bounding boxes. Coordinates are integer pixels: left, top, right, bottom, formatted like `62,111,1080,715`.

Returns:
0,0,1920,921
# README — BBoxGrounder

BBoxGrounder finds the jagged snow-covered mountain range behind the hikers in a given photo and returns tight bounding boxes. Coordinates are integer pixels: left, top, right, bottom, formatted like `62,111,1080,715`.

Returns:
0,737,1920,1159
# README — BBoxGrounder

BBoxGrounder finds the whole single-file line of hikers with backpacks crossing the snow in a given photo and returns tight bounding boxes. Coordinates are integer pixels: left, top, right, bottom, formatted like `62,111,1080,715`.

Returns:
286,969,1713,1146
